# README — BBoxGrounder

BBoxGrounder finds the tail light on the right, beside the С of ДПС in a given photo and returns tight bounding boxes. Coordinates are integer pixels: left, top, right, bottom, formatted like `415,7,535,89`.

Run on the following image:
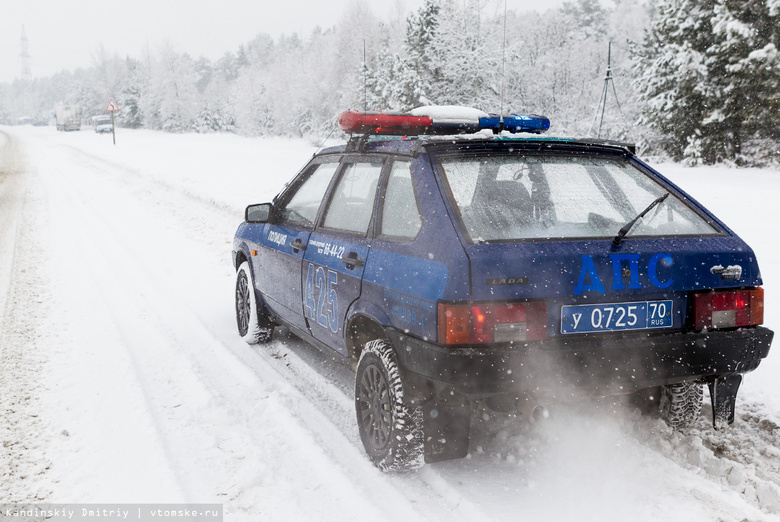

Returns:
693,288,764,330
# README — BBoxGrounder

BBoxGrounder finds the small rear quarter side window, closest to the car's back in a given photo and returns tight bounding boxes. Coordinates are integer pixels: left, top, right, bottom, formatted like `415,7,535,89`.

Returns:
379,161,422,239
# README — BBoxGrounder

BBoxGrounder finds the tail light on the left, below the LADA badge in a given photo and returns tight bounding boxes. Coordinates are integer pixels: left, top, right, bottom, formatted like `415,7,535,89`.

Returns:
438,301,547,344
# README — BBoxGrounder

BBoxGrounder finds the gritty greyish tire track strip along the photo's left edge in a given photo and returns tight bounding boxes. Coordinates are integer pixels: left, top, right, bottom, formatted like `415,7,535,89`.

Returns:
0,128,50,502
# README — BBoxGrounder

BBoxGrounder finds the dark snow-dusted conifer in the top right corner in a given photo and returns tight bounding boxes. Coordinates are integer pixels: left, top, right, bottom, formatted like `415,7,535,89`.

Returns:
636,0,780,163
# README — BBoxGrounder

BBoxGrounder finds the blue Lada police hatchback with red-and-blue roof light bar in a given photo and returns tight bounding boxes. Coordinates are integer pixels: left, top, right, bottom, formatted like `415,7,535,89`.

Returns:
233,107,773,470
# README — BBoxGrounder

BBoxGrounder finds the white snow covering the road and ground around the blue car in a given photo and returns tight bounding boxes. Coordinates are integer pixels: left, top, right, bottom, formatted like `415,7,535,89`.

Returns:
0,127,780,521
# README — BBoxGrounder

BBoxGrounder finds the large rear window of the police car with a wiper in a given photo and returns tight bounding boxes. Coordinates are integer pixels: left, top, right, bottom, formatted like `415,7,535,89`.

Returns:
437,153,720,242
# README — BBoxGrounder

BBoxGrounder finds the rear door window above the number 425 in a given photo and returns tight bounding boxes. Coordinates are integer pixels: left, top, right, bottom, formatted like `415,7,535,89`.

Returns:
322,162,382,236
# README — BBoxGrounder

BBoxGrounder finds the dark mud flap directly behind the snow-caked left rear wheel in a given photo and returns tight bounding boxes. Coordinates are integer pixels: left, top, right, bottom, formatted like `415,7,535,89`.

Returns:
423,400,471,463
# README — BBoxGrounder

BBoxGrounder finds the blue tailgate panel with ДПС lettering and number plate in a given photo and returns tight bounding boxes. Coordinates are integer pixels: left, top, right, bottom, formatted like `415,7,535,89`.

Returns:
466,237,761,337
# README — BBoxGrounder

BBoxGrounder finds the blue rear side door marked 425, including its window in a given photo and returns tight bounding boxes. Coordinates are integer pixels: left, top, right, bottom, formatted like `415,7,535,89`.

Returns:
302,157,384,355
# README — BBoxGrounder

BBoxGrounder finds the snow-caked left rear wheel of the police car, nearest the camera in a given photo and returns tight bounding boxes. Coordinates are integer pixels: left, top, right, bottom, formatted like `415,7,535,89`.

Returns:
355,339,425,471
